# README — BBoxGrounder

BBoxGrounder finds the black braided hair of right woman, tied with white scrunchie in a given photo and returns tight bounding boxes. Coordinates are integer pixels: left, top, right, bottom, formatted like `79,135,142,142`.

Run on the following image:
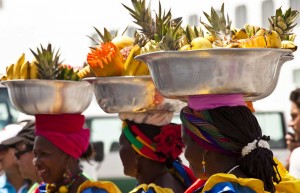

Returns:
209,106,281,193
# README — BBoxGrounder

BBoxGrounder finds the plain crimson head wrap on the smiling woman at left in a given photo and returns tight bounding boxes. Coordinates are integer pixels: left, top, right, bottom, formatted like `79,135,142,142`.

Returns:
35,114,90,159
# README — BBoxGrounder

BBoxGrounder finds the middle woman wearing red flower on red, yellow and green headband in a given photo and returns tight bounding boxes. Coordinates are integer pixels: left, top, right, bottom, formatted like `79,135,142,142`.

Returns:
119,112,195,193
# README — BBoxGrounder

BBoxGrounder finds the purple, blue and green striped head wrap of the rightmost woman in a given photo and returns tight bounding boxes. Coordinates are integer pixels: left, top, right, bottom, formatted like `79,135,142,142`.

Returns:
180,106,241,156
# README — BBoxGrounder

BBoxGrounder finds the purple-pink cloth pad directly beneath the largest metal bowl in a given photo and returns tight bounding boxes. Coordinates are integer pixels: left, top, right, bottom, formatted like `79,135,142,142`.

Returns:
188,94,246,111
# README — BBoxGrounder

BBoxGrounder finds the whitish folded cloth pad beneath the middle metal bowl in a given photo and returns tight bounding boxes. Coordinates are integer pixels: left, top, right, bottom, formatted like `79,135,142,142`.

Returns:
119,111,174,126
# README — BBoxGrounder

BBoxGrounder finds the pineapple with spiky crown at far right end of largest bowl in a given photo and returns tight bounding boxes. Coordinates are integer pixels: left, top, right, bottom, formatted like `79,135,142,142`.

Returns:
268,7,299,40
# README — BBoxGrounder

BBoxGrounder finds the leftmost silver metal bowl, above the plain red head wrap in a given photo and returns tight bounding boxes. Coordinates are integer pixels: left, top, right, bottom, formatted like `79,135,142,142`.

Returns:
2,80,94,115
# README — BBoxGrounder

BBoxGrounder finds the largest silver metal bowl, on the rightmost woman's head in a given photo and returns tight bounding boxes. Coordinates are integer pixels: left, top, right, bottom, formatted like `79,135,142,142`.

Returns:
135,48,293,101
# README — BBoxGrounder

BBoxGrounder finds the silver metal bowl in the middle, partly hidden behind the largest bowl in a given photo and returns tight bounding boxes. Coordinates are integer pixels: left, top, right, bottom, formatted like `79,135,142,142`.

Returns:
83,76,183,113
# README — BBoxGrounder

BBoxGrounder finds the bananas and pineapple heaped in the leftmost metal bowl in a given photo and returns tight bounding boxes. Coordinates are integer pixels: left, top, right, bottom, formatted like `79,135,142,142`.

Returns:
1,44,91,81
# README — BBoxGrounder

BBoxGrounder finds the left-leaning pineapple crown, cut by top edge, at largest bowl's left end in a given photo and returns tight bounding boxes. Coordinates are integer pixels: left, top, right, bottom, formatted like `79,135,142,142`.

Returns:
122,0,155,39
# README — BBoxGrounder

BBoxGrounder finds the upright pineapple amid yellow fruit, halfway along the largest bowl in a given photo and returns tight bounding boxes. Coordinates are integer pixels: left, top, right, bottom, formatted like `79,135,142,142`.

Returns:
200,3,232,47
